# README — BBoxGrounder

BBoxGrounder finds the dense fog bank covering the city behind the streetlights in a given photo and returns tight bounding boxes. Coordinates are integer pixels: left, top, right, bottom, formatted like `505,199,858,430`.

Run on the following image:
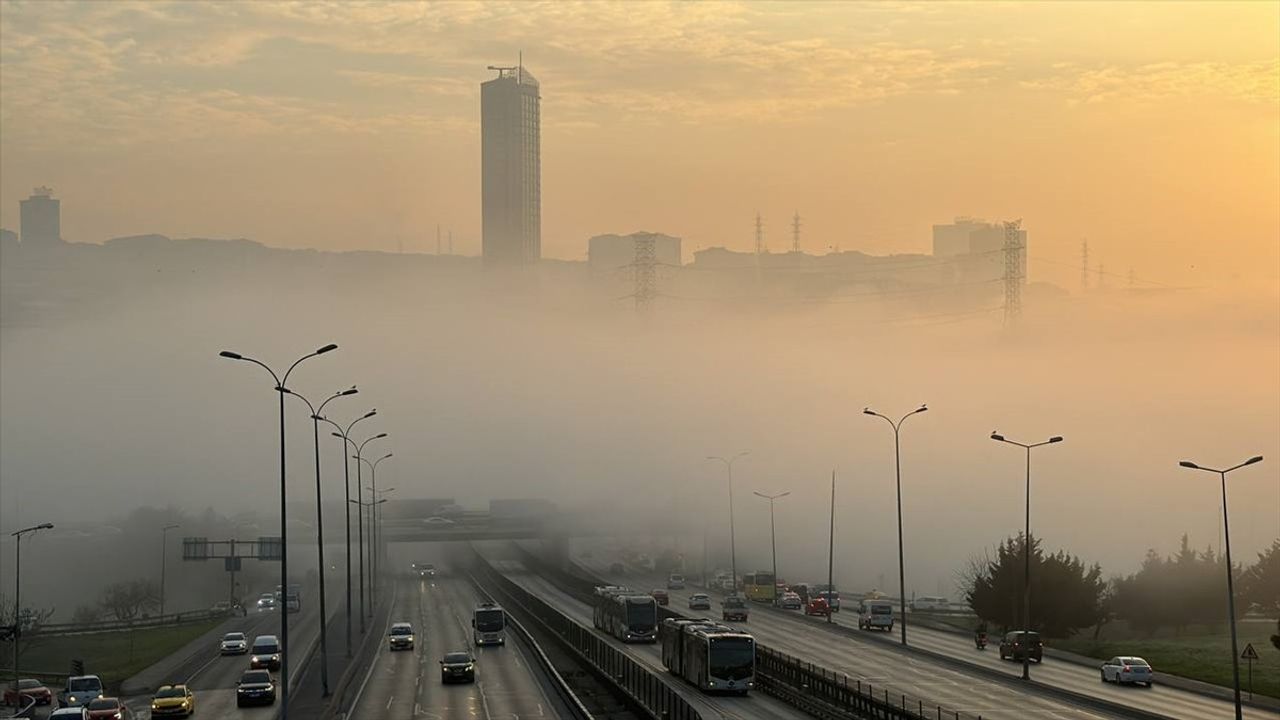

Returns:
0,248,1280,609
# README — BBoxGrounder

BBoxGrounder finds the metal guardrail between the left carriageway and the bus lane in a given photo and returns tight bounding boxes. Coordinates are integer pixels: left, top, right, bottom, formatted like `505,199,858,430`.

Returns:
476,545,701,720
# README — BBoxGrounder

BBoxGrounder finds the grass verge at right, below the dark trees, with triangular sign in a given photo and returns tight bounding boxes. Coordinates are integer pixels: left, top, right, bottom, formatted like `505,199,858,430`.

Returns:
1050,620,1280,698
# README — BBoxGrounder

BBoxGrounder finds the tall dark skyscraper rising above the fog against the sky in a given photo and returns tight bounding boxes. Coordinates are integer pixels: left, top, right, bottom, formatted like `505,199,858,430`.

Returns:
480,64,543,266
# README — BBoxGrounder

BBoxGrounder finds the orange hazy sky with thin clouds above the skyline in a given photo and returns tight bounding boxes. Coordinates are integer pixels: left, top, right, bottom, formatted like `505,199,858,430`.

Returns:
0,1,1280,290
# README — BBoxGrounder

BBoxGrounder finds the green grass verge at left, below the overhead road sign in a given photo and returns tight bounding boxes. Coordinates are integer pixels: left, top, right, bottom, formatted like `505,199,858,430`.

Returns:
9,619,223,687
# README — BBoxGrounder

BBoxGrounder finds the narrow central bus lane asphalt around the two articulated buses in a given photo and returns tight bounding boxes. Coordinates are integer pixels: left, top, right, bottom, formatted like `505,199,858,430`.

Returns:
476,543,809,720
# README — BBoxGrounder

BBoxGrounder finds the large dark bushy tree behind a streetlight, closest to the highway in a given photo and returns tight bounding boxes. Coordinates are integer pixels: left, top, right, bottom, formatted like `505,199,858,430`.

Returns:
965,533,1107,637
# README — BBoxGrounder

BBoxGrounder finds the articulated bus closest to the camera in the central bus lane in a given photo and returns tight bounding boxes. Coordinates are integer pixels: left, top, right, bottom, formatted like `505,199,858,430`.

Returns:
659,618,755,696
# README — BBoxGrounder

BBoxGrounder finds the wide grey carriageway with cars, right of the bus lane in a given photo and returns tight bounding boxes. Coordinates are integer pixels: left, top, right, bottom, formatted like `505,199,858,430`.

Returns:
586,550,1276,720
